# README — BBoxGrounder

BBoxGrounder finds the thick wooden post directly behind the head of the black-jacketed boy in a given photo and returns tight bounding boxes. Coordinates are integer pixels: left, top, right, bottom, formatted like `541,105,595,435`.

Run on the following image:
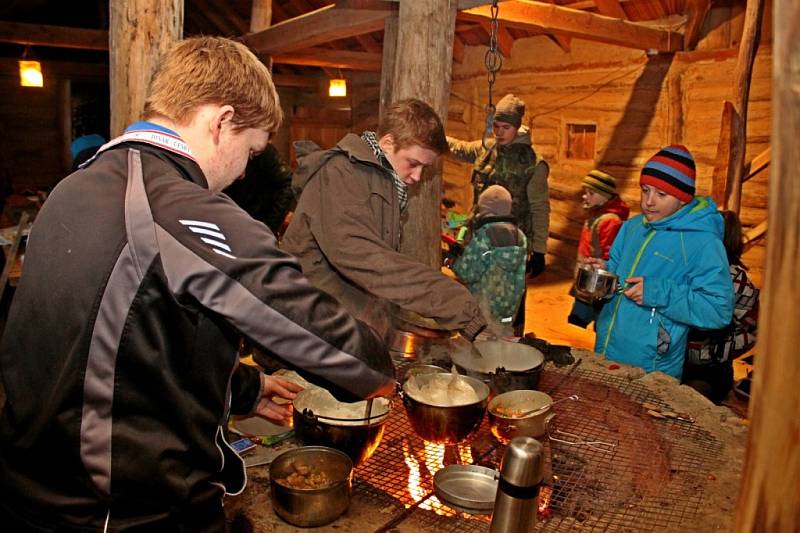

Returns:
109,0,183,137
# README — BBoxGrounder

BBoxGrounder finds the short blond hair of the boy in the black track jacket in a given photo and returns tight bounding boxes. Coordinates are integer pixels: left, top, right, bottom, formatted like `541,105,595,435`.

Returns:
144,37,283,132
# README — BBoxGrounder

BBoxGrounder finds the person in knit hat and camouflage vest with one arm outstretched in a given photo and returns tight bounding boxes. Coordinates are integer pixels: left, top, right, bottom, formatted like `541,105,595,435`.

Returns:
447,94,550,276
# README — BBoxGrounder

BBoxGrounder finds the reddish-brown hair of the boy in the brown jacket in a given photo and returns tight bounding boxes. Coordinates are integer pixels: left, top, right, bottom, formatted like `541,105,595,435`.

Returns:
378,98,449,155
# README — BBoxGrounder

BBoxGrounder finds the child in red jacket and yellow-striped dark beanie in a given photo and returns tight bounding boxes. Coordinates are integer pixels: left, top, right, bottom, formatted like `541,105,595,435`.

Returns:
578,169,630,263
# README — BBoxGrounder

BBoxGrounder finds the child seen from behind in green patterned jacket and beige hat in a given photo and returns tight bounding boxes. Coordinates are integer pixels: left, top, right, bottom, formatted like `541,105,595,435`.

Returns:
453,185,527,334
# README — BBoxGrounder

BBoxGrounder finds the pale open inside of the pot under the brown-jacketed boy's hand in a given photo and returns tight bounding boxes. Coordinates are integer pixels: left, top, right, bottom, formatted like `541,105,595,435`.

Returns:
452,341,544,373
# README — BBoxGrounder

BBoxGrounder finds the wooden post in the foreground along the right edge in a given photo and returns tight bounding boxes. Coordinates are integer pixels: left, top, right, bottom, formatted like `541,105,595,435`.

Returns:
736,0,800,533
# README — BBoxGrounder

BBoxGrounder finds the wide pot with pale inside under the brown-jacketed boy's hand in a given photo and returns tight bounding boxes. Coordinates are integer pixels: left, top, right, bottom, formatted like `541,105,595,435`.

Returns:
451,341,544,394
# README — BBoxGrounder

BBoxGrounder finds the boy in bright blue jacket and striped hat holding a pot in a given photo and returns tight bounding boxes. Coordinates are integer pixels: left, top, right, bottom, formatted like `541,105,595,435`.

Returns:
586,145,733,379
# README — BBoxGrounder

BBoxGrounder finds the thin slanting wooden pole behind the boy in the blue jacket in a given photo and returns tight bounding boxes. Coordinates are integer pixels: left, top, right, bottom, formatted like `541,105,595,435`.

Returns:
725,0,764,213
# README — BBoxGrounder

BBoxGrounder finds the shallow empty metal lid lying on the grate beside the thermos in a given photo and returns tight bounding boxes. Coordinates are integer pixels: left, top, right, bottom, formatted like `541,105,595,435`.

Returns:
433,465,500,514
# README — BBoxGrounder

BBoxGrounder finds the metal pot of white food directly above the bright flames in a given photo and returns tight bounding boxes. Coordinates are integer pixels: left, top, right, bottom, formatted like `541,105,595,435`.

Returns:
402,372,489,444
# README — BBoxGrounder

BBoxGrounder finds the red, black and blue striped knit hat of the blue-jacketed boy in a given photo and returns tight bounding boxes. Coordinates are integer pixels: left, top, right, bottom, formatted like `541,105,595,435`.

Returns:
639,144,695,202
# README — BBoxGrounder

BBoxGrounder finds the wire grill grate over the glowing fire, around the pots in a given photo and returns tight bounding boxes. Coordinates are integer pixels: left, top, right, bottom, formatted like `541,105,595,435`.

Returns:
354,368,722,533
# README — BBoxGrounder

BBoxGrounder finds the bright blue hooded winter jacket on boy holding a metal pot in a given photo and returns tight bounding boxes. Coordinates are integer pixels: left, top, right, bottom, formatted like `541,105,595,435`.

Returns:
595,197,733,379
